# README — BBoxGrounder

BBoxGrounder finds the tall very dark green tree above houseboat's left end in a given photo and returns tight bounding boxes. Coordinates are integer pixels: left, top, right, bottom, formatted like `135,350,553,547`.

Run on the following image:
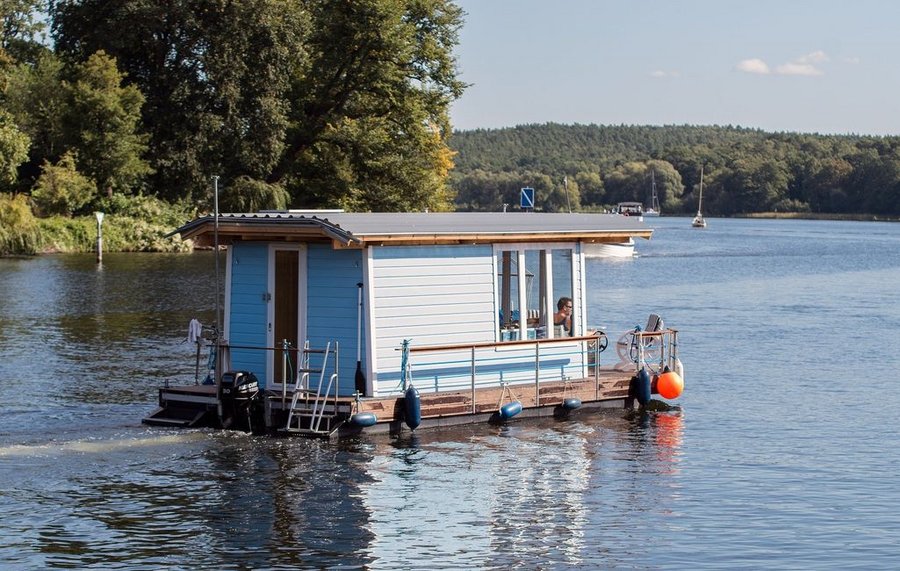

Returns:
53,0,308,200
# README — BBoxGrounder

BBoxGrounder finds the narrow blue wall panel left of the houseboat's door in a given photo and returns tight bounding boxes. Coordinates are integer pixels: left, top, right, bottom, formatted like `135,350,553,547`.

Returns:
226,243,269,386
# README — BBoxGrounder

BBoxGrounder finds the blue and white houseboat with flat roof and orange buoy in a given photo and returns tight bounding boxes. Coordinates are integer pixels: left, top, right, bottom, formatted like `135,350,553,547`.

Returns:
144,211,683,437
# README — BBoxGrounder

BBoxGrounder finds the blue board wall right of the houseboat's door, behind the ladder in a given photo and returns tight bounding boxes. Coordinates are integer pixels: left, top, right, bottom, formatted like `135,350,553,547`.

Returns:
306,244,366,396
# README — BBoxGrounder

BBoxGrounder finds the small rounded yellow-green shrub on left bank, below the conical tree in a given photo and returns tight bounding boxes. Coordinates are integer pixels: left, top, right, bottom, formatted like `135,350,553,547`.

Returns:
31,153,97,216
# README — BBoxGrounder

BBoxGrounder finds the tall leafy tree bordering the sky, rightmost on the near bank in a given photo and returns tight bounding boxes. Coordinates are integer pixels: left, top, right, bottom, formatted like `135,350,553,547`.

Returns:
278,0,464,210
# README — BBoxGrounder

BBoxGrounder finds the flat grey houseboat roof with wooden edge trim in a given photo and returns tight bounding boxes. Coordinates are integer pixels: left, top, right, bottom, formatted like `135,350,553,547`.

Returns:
172,210,653,248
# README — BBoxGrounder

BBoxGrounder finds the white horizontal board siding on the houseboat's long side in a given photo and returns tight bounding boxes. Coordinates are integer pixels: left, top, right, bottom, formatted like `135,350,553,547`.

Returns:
370,245,583,396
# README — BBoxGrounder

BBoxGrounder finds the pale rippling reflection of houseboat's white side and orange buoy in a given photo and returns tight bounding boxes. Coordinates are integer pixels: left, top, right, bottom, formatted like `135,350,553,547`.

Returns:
344,414,681,568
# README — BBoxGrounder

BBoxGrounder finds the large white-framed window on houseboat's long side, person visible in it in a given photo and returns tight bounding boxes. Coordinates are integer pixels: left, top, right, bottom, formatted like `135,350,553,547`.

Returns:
496,247,578,341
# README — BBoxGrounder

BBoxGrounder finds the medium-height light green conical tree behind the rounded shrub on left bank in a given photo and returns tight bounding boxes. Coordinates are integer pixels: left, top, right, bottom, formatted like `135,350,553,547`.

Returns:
65,51,150,199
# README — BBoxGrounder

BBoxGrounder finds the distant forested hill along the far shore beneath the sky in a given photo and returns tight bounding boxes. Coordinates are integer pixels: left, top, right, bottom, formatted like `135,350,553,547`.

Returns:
450,124,900,217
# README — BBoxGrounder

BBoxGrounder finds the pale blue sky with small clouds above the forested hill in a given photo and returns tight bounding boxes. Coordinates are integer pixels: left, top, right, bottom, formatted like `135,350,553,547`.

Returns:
451,0,900,135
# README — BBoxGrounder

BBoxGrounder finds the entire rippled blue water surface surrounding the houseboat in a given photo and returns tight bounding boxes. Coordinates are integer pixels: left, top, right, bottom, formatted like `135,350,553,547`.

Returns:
0,218,900,569
